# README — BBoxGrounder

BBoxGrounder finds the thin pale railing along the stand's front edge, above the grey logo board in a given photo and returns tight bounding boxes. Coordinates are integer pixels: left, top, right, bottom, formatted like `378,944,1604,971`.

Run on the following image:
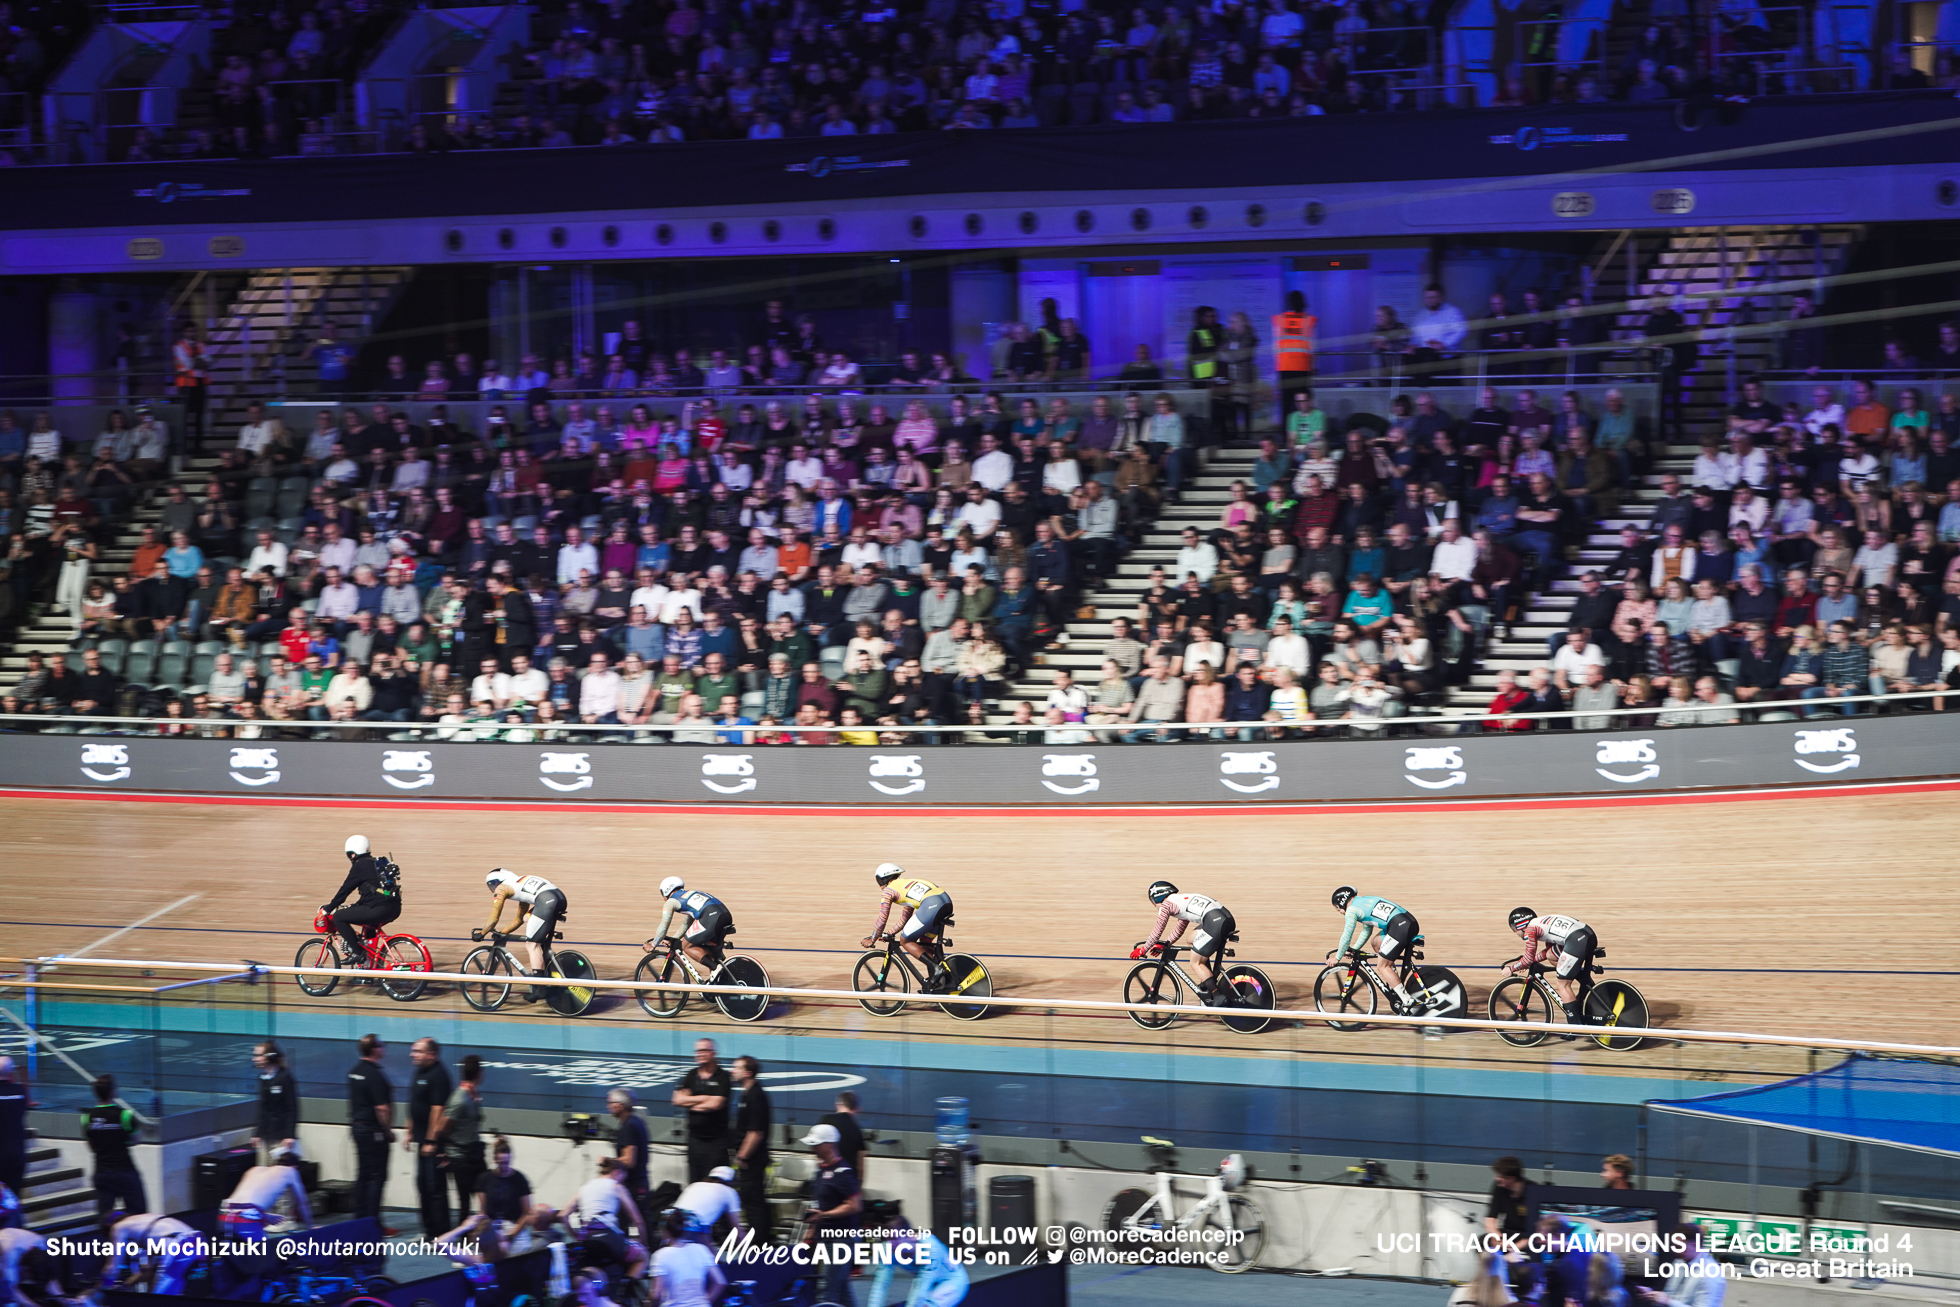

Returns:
0,685,1960,747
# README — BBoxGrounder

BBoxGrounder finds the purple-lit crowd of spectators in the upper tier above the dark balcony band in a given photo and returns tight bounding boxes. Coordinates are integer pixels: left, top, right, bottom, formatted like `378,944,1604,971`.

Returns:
15,0,1960,161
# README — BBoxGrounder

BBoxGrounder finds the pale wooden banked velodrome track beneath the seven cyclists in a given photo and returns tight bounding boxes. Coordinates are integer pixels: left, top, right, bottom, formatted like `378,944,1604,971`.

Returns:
0,790,1960,1080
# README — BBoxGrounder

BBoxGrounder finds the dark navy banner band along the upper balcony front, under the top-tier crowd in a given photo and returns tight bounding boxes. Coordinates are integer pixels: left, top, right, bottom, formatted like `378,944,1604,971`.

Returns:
0,90,1960,231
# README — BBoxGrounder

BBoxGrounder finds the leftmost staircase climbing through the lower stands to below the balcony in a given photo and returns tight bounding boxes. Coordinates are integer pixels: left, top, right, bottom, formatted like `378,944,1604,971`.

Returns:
0,268,414,686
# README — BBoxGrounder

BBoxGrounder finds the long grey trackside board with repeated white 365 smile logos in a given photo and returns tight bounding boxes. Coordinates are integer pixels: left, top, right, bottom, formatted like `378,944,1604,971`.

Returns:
0,713,1960,807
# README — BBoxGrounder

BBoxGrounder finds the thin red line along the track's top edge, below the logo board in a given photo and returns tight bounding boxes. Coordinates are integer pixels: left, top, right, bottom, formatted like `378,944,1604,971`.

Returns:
0,778,1960,817
